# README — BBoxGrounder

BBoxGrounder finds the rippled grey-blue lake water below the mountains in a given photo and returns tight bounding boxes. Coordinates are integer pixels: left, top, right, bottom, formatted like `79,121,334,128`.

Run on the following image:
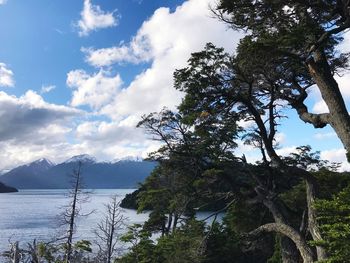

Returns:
0,189,216,256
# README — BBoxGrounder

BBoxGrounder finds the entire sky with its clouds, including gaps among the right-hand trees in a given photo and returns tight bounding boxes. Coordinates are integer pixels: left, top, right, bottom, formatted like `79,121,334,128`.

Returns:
0,0,350,170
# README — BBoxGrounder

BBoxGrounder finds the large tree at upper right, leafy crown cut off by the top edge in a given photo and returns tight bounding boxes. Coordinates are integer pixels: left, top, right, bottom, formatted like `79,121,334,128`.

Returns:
214,0,350,160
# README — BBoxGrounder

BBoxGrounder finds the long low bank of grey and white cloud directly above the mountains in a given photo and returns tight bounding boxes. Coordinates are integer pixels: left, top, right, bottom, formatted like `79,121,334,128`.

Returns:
0,91,151,170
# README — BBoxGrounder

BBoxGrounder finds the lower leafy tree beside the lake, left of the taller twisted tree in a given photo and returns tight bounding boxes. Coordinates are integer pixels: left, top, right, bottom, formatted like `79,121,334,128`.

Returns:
138,110,241,235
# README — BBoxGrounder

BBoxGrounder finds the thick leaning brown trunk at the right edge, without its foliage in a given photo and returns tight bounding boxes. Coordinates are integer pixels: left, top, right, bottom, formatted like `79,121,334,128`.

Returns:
307,49,350,161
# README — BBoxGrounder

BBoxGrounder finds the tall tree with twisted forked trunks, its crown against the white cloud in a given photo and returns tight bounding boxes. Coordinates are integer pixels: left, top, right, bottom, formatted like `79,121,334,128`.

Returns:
175,44,334,262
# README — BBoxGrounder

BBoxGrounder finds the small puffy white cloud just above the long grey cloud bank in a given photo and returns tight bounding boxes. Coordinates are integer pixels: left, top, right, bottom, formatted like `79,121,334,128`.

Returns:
66,70,123,109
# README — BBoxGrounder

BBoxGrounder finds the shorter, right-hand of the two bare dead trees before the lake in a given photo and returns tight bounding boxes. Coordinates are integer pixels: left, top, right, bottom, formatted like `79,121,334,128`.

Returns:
95,195,126,263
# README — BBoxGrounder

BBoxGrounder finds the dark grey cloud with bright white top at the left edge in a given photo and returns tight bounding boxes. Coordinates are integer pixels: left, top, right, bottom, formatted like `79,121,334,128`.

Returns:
0,90,81,144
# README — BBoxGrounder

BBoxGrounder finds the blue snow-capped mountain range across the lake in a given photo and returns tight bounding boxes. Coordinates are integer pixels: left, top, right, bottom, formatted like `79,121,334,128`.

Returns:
0,155,156,189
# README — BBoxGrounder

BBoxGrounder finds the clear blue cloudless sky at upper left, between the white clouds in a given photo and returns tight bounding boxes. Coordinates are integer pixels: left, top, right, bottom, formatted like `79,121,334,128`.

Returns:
0,0,183,100
